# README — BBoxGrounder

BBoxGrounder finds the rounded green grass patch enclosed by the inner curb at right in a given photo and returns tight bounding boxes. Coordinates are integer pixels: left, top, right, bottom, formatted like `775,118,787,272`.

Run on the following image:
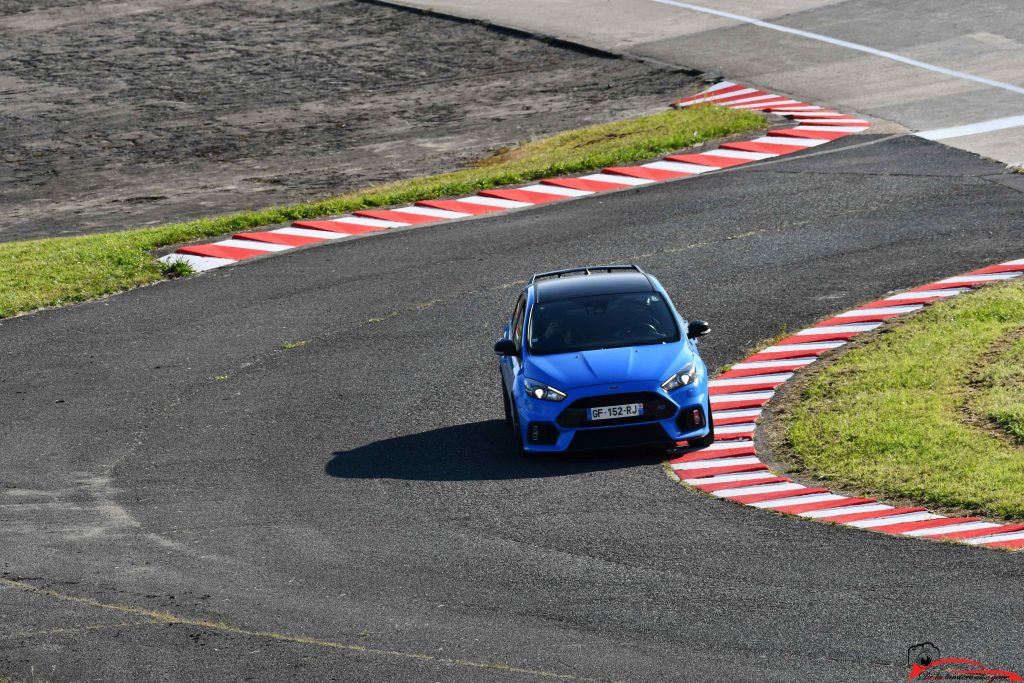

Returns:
781,283,1024,519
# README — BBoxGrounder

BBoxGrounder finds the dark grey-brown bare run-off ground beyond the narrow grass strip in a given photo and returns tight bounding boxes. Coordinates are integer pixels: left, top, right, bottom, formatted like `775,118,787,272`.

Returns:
0,0,696,241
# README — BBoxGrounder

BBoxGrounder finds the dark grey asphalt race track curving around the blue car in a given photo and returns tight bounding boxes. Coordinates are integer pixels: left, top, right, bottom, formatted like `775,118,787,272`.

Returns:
0,135,1024,682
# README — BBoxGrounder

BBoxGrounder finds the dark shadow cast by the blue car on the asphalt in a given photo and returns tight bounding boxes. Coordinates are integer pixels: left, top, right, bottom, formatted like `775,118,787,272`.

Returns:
325,420,665,481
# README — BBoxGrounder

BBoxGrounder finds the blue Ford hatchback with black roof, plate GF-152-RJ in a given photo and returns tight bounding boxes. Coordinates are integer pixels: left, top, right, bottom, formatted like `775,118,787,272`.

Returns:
495,265,715,455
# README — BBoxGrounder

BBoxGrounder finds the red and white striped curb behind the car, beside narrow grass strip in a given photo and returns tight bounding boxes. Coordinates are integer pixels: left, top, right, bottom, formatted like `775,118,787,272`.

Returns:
160,81,869,270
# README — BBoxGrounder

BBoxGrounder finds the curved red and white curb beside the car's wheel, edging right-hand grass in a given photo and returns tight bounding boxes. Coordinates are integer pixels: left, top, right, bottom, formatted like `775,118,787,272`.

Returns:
669,259,1024,549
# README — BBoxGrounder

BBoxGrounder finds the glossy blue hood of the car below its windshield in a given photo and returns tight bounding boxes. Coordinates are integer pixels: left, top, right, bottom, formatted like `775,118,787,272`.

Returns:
523,341,693,391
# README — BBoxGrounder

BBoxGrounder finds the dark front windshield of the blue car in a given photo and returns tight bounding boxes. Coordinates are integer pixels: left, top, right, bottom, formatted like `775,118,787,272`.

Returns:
528,292,679,355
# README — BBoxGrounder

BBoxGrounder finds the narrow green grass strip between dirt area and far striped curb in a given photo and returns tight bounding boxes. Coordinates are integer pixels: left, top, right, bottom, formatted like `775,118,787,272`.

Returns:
0,106,765,317
